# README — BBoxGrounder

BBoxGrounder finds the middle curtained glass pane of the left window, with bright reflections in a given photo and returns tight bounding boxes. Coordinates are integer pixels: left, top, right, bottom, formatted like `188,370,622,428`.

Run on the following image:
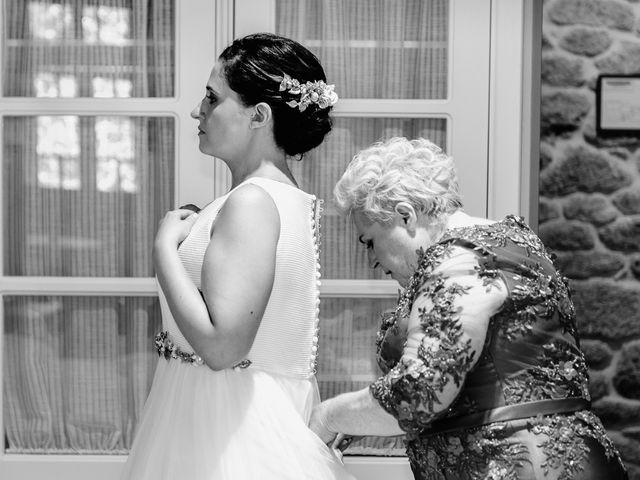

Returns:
2,116,175,277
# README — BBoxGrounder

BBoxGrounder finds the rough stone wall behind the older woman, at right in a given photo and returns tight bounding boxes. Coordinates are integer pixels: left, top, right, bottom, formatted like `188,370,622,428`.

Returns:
539,0,640,474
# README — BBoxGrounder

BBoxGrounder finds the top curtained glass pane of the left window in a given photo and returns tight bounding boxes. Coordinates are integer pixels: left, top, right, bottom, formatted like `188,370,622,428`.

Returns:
1,0,175,97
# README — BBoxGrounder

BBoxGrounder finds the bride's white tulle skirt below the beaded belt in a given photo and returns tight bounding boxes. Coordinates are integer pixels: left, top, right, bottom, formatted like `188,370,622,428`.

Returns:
122,359,355,480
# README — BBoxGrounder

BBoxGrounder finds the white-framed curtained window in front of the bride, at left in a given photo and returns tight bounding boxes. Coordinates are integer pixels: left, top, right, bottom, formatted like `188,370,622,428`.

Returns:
0,0,216,479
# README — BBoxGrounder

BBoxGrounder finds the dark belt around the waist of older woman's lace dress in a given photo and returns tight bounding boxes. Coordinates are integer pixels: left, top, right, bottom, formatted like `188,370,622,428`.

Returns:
422,397,591,436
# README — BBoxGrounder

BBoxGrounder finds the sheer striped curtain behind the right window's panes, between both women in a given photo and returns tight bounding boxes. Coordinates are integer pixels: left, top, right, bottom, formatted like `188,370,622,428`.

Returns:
276,0,450,455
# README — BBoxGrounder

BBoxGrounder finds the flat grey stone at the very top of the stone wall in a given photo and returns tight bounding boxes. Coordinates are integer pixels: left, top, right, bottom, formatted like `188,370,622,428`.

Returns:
547,0,635,31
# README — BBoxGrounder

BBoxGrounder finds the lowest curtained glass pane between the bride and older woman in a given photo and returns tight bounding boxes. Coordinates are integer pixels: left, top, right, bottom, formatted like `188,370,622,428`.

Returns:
318,298,405,455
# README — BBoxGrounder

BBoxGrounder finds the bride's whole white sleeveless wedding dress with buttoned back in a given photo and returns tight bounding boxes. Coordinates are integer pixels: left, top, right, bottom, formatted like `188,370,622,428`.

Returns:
122,178,353,480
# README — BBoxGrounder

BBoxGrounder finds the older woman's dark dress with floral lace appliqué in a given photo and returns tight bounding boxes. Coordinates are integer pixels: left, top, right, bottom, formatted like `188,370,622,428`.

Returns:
371,216,626,480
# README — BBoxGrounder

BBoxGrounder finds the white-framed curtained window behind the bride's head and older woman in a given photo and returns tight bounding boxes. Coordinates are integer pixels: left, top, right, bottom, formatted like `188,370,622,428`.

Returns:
236,0,489,468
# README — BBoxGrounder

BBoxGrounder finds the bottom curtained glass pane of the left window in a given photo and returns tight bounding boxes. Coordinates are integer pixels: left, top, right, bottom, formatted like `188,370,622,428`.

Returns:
3,296,161,454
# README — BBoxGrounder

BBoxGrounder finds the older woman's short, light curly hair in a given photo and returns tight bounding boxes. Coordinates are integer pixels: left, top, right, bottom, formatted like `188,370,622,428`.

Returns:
334,137,462,223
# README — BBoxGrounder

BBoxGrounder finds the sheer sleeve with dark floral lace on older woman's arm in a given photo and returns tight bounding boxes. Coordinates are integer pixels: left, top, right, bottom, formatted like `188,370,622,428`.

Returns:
371,247,507,432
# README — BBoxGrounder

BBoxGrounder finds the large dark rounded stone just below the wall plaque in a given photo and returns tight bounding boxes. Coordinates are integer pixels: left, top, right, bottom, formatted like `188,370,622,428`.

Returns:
540,146,632,197
